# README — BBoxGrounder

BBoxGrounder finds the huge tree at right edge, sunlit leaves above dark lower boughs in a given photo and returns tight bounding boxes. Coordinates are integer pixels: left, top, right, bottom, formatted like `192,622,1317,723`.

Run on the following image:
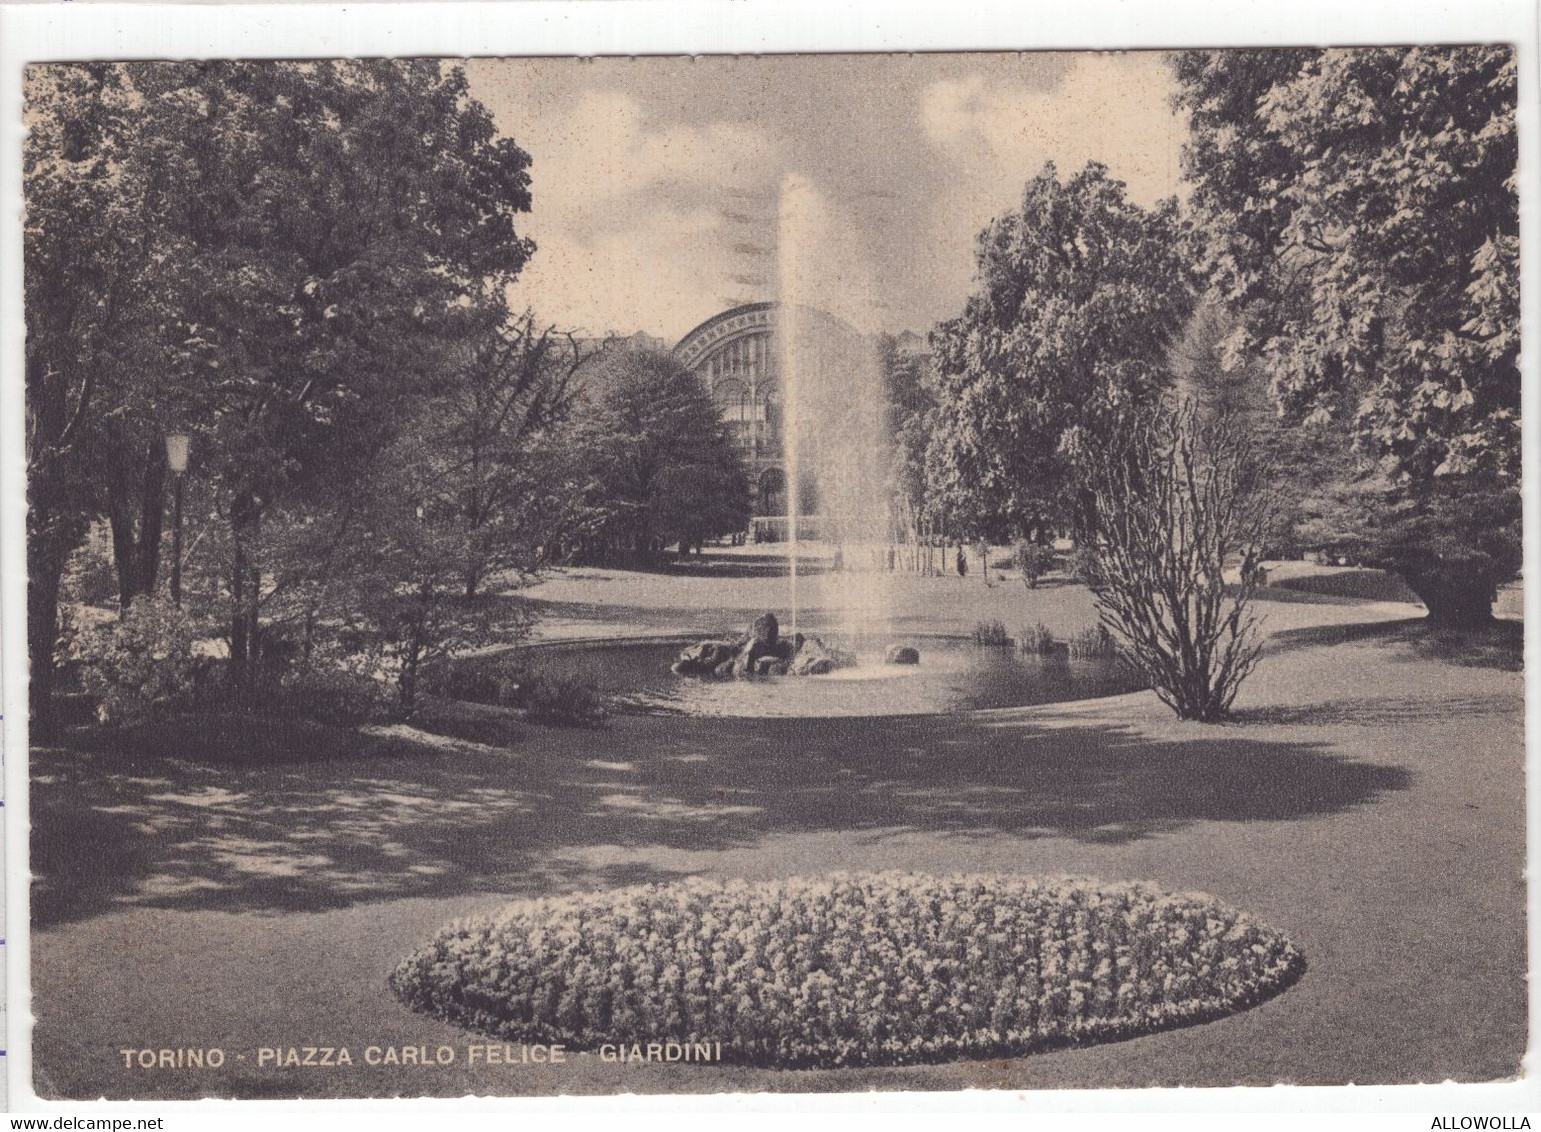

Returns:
1174,46,1519,624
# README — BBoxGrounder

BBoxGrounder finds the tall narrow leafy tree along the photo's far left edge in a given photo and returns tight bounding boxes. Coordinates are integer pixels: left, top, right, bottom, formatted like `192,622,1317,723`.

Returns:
23,63,185,735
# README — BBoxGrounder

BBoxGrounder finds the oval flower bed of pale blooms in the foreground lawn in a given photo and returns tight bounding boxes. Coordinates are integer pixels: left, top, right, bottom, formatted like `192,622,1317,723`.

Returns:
390,873,1305,1066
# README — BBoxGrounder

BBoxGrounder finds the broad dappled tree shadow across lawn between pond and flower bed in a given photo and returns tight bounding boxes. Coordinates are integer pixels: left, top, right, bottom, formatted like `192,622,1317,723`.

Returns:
32,715,1410,927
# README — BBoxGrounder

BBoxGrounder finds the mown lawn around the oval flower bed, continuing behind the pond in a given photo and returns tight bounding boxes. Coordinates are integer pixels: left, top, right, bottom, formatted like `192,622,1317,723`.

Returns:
31,564,1526,1098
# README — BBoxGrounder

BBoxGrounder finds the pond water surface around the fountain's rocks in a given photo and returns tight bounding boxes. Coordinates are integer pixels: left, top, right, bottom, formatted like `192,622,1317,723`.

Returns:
529,636,1145,718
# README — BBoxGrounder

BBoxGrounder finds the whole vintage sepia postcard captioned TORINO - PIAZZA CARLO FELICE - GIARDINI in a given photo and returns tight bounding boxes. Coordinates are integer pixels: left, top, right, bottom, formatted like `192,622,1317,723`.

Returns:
6,26,1527,1101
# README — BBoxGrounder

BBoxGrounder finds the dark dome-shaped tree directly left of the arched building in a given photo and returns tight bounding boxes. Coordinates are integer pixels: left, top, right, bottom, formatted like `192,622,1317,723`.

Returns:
582,350,749,564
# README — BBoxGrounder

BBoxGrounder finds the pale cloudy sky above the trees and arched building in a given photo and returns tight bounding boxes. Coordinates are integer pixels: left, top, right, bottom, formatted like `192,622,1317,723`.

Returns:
467,52,1187,342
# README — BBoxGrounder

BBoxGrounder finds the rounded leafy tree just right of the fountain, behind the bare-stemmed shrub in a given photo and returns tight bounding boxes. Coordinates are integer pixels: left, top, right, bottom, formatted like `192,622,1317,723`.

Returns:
928,163,1193,538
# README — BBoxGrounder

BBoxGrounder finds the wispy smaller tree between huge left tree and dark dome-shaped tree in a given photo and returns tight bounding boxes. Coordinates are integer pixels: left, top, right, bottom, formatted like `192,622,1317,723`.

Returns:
243,304,584,716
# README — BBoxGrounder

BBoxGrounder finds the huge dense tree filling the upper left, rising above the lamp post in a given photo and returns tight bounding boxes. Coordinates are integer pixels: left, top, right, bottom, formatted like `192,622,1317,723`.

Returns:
26,60,533,708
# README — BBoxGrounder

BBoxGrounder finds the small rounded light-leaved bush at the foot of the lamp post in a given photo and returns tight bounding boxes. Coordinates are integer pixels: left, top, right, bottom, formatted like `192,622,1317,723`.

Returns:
69,596,197,727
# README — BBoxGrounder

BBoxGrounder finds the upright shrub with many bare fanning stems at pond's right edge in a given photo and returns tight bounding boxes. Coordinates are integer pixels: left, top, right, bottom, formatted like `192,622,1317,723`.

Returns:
1088,405,1274,722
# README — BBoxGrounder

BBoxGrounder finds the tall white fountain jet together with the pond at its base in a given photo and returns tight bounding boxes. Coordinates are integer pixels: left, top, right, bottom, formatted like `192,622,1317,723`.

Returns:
607,174,1137,718
